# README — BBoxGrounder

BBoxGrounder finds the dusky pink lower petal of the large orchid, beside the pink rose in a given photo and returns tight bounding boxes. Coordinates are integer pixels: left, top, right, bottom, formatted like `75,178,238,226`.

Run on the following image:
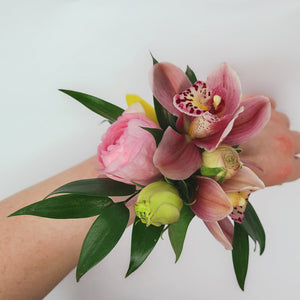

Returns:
153,127,201,180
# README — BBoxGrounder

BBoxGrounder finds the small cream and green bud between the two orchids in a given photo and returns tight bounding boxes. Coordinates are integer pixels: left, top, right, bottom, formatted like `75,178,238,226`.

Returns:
201,145,242,182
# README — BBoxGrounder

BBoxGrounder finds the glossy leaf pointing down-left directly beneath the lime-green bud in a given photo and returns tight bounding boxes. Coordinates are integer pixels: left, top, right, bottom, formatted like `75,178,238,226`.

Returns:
126,217,164,277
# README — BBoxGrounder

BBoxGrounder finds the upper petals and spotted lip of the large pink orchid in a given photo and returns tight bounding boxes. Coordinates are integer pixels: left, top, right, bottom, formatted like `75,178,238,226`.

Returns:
150,63,270,151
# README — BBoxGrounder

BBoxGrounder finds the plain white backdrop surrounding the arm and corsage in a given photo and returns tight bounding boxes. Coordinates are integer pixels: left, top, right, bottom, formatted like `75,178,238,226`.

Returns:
0,0,300,300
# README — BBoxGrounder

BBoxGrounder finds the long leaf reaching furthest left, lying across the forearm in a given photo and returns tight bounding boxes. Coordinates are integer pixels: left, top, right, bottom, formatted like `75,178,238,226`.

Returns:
10,194,113,219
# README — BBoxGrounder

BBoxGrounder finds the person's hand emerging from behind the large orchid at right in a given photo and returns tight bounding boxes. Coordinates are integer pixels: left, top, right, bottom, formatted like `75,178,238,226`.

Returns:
240,95,300,186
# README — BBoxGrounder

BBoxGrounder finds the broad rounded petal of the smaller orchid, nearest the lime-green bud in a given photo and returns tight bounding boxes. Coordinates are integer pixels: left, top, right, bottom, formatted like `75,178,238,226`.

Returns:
191,176,233,221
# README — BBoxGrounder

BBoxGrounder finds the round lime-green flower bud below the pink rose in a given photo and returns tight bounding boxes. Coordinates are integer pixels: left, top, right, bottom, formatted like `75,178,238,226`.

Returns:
134,181,183,226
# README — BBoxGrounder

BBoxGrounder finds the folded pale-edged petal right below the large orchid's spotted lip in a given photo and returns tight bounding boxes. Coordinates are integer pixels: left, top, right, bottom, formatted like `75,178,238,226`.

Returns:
193,107,243,151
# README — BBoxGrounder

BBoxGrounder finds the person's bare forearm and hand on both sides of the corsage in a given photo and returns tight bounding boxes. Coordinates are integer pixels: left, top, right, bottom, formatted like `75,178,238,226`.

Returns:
0,100,300,300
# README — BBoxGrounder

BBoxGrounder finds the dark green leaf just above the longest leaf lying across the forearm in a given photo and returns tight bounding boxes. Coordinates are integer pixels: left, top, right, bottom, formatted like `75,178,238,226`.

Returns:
47,178,136,197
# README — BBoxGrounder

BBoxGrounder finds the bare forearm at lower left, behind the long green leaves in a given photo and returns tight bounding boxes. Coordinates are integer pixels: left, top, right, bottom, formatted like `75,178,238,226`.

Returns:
0,157,101,300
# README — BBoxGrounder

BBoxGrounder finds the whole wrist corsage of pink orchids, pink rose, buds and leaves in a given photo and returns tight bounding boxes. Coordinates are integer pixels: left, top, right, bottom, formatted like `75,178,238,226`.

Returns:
11,58,270,289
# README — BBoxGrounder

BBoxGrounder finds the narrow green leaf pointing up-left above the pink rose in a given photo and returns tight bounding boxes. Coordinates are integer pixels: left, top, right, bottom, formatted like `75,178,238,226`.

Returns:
59,89,124,122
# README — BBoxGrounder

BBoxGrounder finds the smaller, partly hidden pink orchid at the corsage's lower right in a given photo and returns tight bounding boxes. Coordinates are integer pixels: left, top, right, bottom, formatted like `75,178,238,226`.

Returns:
191,167,264,250
